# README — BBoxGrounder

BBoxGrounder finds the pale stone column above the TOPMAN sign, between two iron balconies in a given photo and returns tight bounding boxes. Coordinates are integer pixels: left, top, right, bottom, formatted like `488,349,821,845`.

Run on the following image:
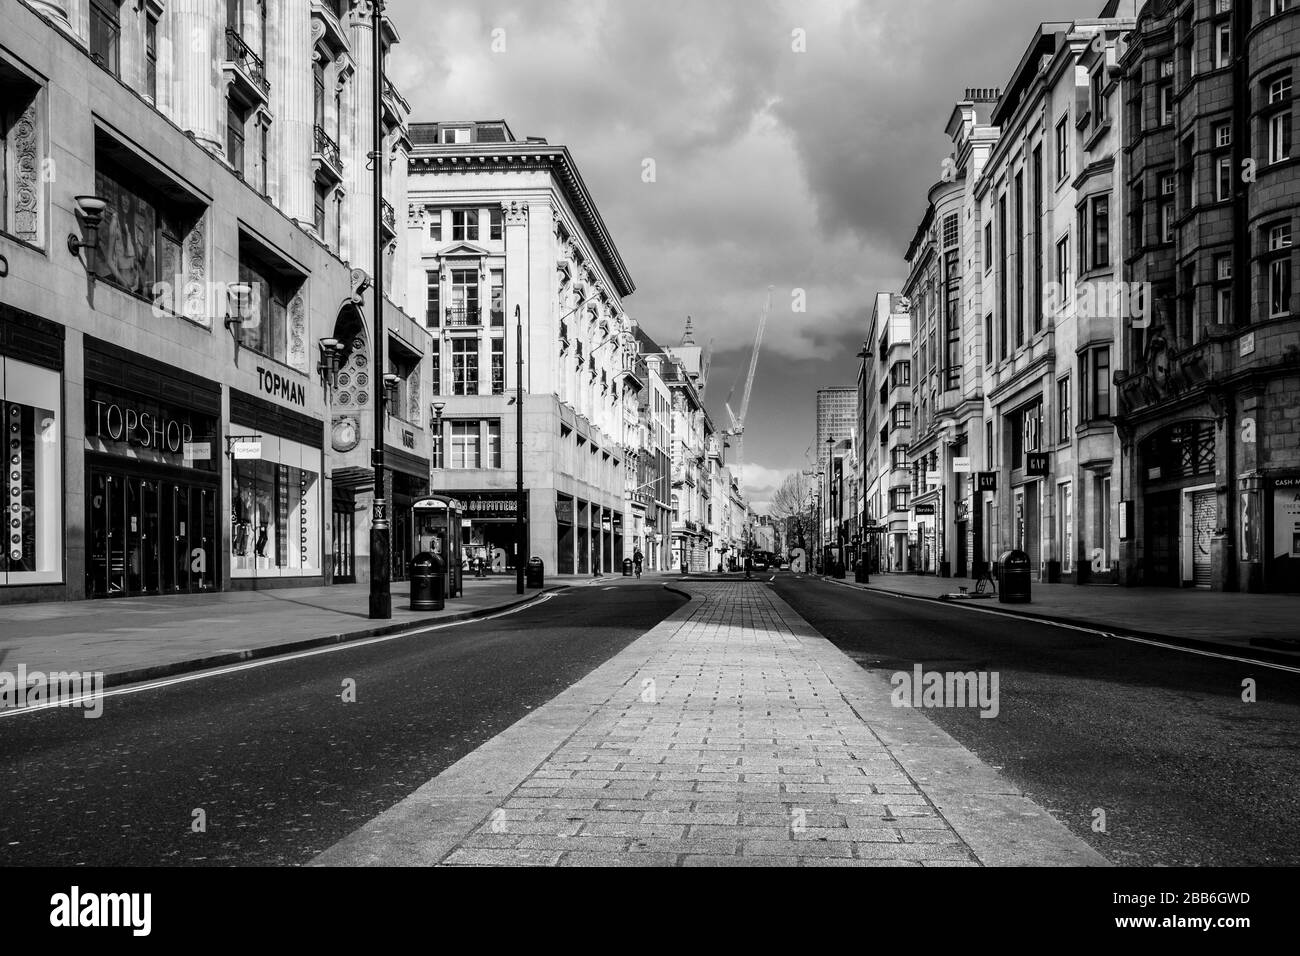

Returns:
265,3,316,226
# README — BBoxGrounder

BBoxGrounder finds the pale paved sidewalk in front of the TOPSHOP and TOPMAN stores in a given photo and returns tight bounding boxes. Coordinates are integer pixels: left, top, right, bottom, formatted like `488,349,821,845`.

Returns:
0,575,584,687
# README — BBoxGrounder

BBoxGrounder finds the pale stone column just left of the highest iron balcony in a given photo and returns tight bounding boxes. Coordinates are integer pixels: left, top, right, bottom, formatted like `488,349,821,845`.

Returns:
167,0,226,155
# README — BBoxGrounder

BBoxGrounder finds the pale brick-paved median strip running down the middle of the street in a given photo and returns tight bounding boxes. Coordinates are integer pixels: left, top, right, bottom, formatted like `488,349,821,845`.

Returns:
313,583,1105,866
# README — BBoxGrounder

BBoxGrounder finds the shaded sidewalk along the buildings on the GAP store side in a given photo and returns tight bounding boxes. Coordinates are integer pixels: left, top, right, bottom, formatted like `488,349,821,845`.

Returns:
827,574,1300,662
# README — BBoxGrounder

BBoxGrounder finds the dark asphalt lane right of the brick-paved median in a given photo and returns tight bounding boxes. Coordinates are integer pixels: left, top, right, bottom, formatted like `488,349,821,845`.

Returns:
772,575,1300,866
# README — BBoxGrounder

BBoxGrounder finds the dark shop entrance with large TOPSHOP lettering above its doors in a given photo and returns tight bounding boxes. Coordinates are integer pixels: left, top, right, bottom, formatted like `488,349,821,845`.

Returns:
85,337,221,597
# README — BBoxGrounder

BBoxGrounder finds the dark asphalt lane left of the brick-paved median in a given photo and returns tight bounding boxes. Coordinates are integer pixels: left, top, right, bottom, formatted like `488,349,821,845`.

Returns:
0,579,684,866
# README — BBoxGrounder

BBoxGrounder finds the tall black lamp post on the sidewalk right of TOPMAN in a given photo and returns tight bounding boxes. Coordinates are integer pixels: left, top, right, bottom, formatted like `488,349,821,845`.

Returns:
371,0,393,620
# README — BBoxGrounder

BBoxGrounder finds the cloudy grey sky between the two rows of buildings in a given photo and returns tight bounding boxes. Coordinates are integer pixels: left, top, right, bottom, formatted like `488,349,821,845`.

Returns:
389,0,1104,502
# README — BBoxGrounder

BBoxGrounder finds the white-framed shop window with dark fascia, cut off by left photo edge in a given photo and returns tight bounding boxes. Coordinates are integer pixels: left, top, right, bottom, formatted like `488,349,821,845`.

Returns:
0,306,64,601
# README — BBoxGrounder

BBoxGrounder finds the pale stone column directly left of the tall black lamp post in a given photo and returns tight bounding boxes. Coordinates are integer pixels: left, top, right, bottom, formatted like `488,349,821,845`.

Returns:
339,0,374,274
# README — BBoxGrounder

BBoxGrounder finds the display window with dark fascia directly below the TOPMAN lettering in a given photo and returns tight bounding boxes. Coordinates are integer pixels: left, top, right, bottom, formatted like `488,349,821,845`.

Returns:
224,389,325,589
